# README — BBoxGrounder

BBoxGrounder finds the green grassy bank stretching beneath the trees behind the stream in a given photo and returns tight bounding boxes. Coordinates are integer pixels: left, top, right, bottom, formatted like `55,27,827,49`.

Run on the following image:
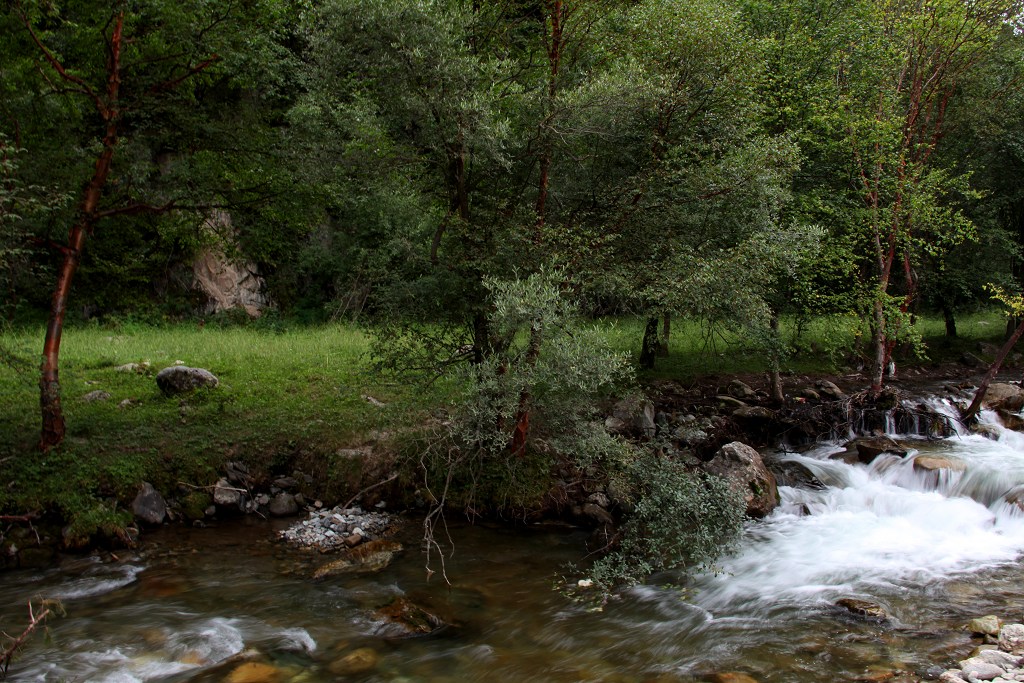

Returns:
0,313,1002,536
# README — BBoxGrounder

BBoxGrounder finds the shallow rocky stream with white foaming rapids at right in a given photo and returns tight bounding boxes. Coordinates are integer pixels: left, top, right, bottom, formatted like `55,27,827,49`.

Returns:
6,403,1024,683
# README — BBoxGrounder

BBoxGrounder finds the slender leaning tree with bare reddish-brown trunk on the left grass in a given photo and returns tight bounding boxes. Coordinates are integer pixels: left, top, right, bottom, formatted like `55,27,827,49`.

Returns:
11,3,241,451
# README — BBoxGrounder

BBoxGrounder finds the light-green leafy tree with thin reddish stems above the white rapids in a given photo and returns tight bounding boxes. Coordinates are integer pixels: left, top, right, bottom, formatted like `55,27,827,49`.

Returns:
836,0,1020,391
